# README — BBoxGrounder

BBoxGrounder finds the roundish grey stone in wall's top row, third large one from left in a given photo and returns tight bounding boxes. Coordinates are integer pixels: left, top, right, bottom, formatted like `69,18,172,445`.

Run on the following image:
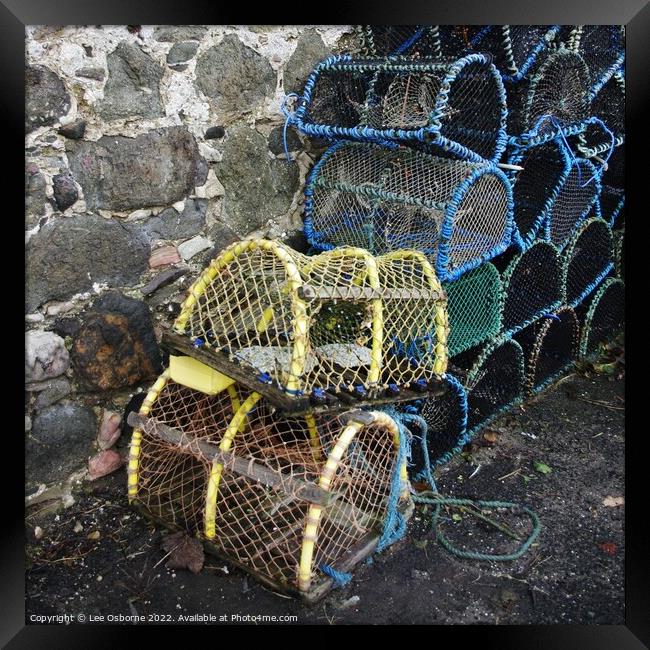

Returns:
196,34,275,113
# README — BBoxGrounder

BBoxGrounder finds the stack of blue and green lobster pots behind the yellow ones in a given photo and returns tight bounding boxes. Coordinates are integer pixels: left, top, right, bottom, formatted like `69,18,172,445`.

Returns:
291,25,625,479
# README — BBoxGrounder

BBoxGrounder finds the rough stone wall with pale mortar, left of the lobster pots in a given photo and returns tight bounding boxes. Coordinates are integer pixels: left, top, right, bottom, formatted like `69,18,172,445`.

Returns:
25,25,353,503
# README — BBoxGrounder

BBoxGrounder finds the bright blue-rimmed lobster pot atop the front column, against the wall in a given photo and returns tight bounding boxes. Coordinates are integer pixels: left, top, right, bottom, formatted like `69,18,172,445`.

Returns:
294,55,506,160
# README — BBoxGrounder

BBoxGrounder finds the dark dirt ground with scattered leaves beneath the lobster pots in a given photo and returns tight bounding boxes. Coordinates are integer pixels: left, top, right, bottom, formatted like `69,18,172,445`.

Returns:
26,368,625,624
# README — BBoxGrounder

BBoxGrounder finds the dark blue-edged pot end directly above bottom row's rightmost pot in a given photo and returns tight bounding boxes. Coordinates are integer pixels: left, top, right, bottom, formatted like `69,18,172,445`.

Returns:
562,218,614,307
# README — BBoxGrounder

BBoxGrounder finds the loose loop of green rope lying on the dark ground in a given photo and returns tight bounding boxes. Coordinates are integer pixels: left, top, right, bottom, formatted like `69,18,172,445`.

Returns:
413,490,542,562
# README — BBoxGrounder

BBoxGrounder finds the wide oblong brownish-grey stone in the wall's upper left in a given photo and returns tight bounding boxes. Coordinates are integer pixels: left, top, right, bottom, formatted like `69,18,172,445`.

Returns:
66,126,201,210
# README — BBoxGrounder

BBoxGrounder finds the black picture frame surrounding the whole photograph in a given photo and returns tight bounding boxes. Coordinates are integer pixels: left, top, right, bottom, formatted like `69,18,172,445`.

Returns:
6,0,650,650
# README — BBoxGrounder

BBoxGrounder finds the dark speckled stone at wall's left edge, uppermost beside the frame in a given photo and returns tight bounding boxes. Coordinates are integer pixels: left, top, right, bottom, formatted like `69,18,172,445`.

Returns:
25,65,70,132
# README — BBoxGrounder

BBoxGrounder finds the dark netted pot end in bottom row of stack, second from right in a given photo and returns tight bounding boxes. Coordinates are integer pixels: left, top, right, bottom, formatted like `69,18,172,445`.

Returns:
515,307,579,395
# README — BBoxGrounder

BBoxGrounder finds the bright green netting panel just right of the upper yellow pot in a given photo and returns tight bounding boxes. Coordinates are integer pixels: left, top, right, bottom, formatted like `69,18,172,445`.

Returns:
443,263,502,356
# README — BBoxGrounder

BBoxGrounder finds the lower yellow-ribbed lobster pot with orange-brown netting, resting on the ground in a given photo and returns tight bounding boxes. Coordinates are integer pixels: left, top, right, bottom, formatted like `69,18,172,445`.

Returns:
128,369,412,600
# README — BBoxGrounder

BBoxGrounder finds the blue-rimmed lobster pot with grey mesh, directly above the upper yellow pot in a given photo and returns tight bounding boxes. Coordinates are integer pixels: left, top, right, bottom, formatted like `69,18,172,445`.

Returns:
305,143,512,279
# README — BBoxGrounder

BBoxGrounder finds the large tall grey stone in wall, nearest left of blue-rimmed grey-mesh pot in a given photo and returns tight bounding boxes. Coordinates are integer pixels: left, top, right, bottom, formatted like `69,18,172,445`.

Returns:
214,126,299,236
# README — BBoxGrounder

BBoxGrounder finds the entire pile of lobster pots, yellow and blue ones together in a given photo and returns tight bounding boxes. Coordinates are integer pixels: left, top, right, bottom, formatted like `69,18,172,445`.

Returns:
129,25,624,601
